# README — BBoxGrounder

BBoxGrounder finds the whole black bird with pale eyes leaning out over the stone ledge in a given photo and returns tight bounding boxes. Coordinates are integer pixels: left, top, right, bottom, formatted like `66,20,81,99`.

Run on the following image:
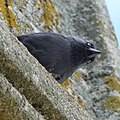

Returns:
18,32,101,83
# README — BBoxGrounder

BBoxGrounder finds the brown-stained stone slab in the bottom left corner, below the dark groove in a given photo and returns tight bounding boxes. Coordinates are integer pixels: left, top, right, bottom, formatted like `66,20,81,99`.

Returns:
0,74,45,120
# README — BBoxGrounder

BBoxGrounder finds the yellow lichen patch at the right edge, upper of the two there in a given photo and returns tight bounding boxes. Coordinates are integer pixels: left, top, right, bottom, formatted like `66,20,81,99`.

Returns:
104,77,120,93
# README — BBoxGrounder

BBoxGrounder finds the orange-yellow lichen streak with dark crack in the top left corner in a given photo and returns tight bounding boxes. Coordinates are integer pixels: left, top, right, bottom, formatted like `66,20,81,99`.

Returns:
0,0,18,29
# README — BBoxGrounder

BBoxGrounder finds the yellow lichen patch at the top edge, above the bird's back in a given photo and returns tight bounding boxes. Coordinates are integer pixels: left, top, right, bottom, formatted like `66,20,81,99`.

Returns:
37,0,59,30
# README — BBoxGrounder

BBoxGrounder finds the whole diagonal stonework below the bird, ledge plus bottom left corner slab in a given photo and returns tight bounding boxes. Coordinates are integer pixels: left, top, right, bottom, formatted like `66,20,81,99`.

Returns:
0,21,94,120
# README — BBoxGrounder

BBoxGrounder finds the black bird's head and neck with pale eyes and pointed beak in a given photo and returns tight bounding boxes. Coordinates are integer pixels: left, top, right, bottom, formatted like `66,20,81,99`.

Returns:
69,37,101,68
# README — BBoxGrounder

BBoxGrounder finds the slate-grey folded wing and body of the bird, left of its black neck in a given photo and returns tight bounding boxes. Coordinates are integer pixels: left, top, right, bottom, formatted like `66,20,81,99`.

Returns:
18,33,70,82
